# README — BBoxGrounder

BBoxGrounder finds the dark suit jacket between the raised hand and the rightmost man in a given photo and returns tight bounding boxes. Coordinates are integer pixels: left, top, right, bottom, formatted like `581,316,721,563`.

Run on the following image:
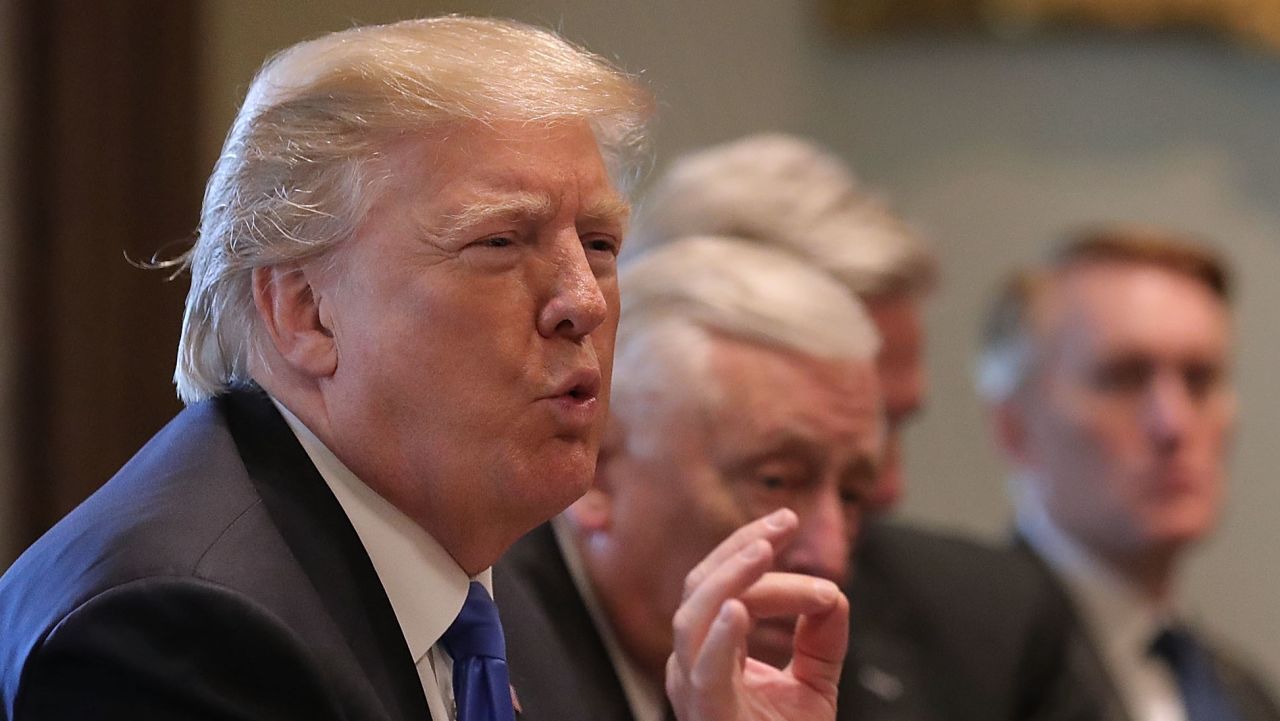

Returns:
840,521,1097,721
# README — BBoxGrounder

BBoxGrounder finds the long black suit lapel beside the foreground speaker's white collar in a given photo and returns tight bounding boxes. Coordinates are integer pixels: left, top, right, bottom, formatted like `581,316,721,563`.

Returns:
219,389,431,721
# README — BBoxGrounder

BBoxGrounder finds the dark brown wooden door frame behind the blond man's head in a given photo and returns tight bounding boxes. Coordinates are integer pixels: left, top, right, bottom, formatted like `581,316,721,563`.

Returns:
12,0,204,553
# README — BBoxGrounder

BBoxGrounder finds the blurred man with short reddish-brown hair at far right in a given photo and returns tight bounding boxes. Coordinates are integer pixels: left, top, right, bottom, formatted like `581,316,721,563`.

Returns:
978,227,1280,721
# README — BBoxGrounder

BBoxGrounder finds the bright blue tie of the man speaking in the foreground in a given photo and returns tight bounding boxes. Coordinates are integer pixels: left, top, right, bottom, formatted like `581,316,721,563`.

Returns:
440,581,516,721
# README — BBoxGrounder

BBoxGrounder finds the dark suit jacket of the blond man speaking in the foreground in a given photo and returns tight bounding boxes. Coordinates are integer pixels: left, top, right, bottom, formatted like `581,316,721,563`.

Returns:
0,391,430,721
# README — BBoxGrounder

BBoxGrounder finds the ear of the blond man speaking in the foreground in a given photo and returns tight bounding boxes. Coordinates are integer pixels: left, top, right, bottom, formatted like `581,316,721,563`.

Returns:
253,264,338,378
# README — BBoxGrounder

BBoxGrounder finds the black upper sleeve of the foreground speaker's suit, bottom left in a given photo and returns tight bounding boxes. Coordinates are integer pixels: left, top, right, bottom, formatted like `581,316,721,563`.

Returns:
12,576,349,721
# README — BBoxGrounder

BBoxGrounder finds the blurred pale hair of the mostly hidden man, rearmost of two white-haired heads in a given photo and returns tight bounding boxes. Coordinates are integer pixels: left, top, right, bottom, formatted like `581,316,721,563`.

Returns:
631,133,936,298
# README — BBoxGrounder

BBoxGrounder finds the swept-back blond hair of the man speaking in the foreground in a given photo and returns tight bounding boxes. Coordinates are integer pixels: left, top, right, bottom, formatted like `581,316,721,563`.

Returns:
172,15,652,403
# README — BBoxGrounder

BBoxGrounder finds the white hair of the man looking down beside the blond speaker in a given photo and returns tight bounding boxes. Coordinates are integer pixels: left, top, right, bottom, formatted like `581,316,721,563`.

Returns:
612,237,879,450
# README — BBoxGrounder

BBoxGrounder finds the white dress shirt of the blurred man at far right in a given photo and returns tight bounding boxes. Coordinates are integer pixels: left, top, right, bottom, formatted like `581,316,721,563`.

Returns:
1018,483,1187,721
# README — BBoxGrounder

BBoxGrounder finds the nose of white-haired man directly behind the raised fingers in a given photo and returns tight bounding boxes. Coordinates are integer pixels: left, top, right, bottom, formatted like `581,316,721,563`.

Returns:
778,489,858,584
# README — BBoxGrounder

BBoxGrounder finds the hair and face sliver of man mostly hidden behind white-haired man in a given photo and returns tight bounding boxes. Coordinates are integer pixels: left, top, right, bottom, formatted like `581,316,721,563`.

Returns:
637,134,937,511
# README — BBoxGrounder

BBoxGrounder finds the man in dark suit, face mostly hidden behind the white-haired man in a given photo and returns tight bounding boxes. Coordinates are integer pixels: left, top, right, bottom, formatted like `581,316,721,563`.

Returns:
627,134,1092,721
